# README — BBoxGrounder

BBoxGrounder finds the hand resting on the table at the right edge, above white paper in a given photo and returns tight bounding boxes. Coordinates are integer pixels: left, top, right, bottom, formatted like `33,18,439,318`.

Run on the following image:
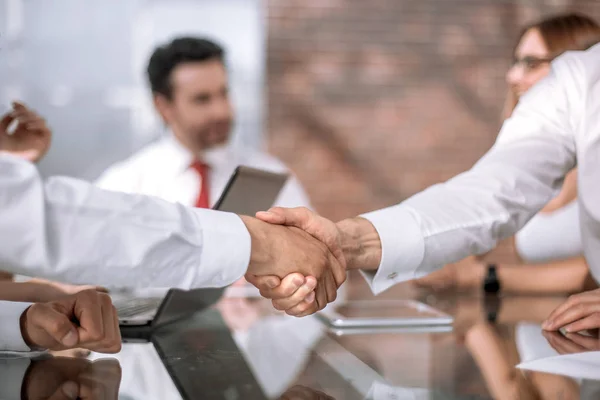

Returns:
542,289,600,333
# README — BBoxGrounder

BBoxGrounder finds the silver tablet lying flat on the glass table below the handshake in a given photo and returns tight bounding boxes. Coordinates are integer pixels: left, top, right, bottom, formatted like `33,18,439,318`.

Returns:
318,300,453,328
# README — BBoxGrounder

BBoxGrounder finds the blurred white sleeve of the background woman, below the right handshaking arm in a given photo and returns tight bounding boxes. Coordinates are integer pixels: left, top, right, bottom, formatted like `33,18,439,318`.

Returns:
515,201,583,263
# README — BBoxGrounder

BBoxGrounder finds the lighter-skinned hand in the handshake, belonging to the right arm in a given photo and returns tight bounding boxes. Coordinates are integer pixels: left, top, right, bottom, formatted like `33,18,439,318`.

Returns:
246,207,381,316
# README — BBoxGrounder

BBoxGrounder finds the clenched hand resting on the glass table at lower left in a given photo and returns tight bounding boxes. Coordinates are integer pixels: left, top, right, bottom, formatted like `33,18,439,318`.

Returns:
21,290,121,353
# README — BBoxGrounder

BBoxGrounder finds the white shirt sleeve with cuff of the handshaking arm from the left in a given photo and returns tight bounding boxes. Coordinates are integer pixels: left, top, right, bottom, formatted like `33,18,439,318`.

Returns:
0,155,250,288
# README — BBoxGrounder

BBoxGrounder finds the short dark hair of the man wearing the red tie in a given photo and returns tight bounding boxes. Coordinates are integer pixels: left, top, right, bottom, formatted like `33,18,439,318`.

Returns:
146,37,225,98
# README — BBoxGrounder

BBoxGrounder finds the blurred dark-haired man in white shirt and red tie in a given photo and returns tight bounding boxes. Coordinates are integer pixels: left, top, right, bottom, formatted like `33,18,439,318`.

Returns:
96,37,310,208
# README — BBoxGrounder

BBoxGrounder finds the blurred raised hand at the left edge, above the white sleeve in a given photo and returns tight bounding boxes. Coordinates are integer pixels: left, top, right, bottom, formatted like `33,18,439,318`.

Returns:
0,101,52,162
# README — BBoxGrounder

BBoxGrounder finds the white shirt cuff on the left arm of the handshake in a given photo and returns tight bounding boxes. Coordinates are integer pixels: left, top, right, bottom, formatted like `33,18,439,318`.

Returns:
193,209,251,287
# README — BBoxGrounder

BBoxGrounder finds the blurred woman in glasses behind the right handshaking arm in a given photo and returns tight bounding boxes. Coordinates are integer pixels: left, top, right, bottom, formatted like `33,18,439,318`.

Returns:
416,14,600,294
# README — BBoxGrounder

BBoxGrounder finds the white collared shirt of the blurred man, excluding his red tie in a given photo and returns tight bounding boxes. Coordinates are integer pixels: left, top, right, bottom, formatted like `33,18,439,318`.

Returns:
96,133,310,207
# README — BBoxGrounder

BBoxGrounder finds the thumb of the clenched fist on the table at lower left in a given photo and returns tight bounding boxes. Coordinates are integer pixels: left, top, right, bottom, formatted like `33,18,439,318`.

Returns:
27,304,79,348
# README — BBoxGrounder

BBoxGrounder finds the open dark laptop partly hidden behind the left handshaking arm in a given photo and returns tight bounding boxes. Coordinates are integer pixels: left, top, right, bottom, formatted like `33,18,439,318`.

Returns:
111,166,288,333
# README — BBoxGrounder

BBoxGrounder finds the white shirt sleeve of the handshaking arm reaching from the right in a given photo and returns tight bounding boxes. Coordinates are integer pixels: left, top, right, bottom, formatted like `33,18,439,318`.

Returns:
364,54,587,293
